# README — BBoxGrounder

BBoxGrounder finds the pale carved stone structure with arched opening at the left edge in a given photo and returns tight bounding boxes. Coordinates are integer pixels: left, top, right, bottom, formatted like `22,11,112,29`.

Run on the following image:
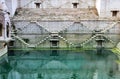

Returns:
0,0,11,57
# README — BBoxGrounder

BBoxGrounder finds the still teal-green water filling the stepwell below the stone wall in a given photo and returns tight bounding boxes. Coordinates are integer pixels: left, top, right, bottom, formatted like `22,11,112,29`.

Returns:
0,50,120,79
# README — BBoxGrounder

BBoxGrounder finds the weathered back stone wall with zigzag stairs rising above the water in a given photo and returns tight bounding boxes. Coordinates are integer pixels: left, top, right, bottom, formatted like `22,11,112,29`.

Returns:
1,0,120,48
